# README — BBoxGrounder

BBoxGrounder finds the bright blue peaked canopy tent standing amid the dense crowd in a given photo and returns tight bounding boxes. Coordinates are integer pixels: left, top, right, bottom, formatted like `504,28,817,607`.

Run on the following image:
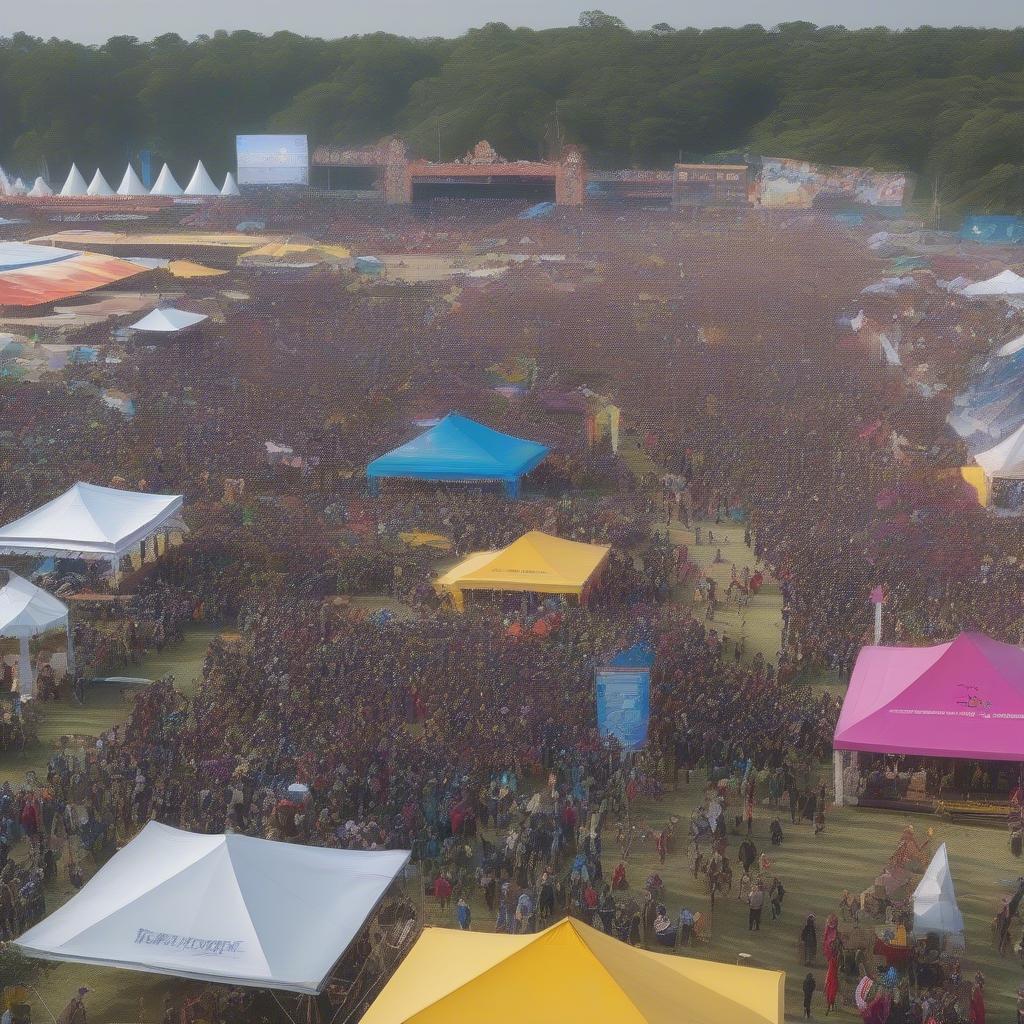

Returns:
367,413,549,498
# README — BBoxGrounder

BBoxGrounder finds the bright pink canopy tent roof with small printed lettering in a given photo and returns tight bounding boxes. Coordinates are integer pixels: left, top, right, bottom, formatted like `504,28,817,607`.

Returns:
834,633,1024,761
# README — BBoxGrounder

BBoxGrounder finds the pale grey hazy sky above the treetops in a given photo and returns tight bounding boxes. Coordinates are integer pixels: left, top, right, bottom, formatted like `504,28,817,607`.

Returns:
8,0,1024,43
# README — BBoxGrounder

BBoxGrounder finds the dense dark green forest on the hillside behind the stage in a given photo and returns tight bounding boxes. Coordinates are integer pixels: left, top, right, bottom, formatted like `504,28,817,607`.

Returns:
6,18,1024,212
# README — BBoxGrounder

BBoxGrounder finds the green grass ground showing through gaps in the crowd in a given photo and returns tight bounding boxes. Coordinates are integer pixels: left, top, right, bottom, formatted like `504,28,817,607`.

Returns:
0,522,1020,1024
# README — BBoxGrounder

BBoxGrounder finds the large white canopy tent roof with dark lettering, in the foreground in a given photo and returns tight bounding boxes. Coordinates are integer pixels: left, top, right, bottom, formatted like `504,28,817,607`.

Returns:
15,821,409,994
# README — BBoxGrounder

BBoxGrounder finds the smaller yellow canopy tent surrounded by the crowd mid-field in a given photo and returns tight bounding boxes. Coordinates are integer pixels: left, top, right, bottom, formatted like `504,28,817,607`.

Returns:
434,529,611,611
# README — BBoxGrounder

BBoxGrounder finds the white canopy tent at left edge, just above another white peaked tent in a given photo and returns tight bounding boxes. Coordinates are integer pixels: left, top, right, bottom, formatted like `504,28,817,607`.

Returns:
0,483,184,573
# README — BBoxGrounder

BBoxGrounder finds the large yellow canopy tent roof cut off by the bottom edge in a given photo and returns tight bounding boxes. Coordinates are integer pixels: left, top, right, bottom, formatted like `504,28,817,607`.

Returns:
362,919,785,1024
